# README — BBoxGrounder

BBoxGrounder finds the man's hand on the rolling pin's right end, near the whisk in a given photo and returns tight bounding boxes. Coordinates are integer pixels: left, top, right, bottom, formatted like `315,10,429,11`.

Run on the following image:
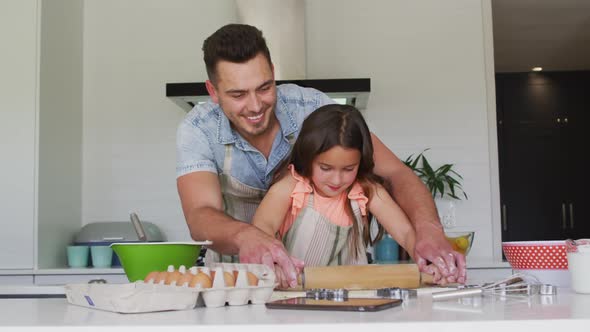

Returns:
414,223,467,284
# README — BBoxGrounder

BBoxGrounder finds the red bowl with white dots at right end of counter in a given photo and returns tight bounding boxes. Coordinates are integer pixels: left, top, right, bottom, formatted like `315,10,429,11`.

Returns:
502,240,570,287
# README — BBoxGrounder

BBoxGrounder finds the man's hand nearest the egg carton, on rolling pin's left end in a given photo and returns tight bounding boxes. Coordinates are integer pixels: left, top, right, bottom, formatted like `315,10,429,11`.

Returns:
239,226,303,288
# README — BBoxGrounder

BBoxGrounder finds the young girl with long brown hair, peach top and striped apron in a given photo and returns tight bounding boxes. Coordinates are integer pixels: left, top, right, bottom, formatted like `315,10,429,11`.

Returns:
253,104,426,288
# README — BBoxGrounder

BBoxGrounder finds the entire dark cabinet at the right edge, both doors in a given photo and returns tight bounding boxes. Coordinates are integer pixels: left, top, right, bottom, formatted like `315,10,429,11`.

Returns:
496,71,590,241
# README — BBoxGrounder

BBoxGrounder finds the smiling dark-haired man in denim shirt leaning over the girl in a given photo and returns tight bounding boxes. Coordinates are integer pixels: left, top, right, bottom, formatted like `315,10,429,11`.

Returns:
177,24,465,287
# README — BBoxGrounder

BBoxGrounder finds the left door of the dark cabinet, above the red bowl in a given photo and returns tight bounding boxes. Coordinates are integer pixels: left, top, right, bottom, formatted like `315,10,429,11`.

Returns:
498,75,567,241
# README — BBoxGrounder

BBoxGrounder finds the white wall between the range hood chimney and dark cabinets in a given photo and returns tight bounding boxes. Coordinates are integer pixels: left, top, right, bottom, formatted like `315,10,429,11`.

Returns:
306,0,495,259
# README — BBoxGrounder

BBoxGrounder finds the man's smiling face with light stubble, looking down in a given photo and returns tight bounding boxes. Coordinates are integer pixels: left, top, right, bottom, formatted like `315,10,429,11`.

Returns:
207,54,277,140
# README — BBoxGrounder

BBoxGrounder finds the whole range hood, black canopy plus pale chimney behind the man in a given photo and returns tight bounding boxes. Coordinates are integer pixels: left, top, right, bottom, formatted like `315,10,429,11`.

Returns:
166,0,371,112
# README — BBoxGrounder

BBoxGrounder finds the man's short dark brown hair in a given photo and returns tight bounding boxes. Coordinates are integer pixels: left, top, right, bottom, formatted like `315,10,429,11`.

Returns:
203,24,272,83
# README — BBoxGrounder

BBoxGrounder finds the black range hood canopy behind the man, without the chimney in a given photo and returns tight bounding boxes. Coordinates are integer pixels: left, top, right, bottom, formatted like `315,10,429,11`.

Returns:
166,78,371,112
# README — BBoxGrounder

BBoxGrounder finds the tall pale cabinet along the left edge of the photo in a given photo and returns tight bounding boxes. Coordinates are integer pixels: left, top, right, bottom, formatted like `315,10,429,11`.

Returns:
0,0,83,272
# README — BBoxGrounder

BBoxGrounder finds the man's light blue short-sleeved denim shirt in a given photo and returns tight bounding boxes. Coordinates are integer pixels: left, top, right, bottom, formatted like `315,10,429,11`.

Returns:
176,84,334,190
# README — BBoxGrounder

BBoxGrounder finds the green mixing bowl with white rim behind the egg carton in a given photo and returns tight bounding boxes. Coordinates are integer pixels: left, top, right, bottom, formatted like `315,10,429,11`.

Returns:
111,241,212,282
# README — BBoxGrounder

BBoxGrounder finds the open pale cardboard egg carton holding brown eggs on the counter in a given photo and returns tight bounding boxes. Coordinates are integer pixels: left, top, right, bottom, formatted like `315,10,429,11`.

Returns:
65,263,276,313
